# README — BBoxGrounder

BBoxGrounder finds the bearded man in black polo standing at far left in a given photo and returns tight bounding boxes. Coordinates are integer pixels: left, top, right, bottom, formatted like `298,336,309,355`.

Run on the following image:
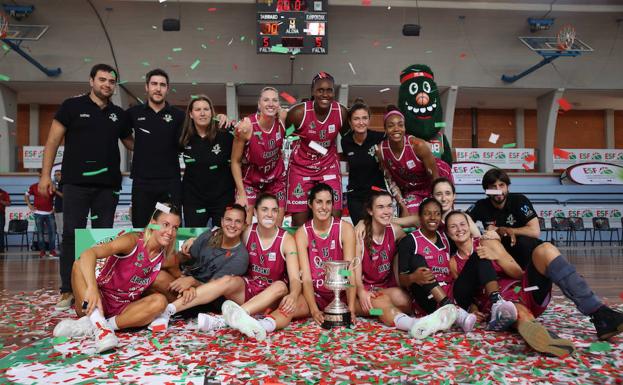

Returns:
39,64,133,308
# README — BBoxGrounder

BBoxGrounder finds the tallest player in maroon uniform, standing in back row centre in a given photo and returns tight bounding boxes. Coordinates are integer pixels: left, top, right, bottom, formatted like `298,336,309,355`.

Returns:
285,72,347,227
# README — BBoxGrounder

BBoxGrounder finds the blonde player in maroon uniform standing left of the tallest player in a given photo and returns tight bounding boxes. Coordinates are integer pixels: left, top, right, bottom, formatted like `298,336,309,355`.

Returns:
231,87,286,225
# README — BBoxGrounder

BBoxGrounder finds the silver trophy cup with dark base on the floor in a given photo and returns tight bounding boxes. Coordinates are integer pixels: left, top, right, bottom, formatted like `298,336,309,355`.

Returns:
322,259,358,329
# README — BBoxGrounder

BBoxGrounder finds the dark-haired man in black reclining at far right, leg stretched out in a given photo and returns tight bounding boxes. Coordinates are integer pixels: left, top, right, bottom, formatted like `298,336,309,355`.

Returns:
467,168,623,340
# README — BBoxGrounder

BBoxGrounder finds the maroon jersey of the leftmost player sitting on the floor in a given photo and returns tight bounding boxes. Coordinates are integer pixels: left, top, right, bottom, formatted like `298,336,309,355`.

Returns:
97,234,164,306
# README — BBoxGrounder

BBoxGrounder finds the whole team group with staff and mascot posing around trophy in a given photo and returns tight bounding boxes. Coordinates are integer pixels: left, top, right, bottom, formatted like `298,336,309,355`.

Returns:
37,64,623,357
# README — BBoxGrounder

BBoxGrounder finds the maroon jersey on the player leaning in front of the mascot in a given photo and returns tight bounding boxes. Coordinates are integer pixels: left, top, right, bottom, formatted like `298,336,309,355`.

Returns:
381,135,431,191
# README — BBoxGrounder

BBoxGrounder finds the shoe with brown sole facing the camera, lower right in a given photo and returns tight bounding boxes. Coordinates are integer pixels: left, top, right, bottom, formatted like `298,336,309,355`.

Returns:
517,320,575,357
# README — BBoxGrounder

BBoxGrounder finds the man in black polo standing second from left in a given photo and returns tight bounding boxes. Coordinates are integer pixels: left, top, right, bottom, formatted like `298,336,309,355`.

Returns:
127,69,185,228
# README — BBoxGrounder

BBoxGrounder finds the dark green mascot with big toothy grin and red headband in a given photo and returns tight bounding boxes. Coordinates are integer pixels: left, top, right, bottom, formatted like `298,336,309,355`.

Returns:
398,64,452,165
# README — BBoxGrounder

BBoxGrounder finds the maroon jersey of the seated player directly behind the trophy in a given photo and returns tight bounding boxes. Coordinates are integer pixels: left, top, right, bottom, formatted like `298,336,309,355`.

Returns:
305,217,344,297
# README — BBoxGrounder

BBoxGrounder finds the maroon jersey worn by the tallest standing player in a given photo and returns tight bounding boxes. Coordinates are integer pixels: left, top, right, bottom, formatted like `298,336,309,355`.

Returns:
290,101,342,170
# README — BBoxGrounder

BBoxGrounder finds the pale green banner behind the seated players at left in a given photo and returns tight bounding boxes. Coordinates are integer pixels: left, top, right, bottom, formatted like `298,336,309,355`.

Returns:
75,227,209,259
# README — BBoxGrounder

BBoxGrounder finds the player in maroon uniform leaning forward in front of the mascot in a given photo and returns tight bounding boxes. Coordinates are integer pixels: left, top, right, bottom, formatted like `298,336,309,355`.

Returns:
377,106,452,216
